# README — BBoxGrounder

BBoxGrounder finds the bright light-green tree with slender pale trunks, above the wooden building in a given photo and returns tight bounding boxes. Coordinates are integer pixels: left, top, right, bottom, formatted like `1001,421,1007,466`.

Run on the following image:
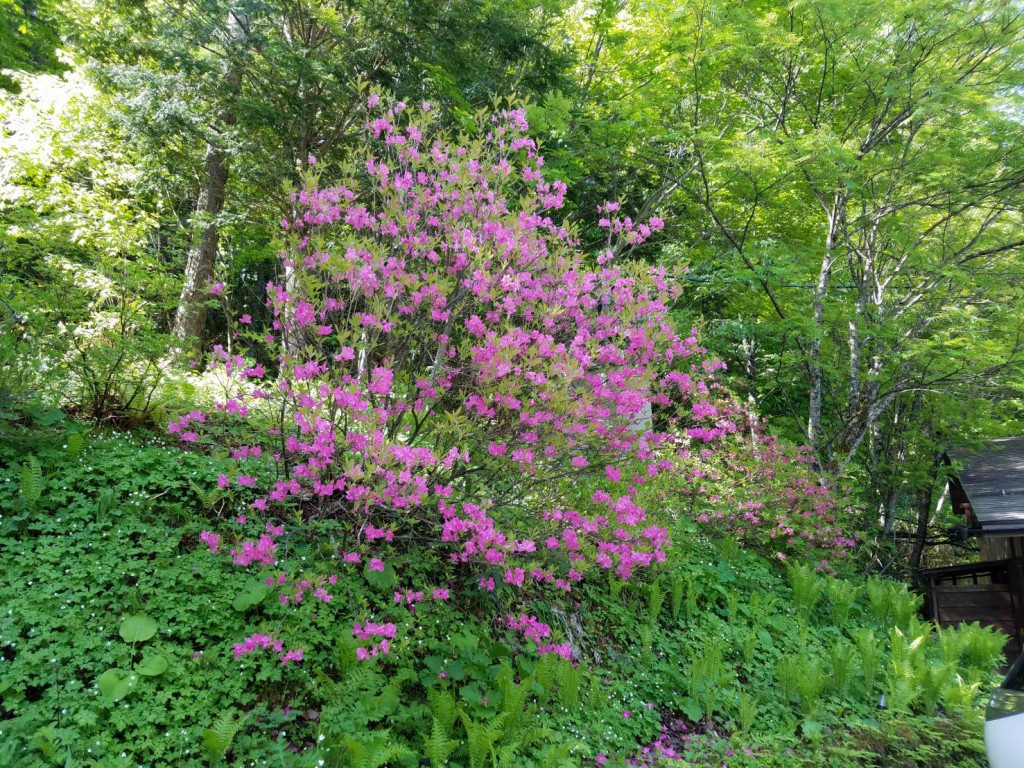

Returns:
567,0,1024,483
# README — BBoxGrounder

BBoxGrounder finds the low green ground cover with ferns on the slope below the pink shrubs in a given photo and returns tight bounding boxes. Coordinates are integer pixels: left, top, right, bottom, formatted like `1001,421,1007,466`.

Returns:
0,424,1001,768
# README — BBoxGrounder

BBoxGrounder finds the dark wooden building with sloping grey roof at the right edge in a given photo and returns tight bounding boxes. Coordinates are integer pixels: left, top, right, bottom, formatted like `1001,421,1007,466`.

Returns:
924,437,1024,663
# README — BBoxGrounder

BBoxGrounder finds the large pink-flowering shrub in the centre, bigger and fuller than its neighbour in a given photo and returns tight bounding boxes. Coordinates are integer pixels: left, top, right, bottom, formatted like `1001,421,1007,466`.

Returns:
169,97,735,657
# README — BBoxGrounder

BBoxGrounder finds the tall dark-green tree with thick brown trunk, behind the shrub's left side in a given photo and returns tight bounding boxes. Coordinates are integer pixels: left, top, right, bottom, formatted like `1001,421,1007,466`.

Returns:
60,0,573,352
